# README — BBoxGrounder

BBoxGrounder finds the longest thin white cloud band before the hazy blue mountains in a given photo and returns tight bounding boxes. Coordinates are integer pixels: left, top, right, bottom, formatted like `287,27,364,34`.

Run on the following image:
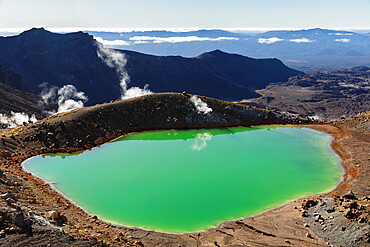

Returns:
130,36,239,43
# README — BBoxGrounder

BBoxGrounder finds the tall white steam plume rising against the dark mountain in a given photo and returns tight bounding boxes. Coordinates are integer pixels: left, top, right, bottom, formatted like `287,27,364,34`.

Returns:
96,39,153,99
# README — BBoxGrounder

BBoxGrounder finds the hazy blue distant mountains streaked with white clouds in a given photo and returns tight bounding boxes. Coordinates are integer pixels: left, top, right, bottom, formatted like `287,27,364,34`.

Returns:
89,28,370,70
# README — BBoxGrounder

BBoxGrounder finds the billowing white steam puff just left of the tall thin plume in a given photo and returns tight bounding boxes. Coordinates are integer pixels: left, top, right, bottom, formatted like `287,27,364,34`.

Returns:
40,83,88,115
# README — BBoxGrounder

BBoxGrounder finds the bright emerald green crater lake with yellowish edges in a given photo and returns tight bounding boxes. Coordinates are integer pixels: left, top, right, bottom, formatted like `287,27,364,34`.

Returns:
23,126,344,233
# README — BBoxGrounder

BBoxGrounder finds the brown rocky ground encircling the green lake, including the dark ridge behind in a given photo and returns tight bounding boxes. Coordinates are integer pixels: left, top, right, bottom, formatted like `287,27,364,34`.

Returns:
0,93,369,246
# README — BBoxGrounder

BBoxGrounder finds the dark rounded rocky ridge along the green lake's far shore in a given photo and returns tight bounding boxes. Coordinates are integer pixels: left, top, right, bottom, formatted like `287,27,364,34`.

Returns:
0,93,313,152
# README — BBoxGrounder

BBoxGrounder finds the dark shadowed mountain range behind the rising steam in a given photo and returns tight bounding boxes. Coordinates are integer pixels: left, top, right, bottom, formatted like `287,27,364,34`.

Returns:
0,28,301,105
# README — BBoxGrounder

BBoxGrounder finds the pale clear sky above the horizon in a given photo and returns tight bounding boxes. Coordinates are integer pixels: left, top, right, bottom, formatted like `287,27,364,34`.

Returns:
0,0,370,29
